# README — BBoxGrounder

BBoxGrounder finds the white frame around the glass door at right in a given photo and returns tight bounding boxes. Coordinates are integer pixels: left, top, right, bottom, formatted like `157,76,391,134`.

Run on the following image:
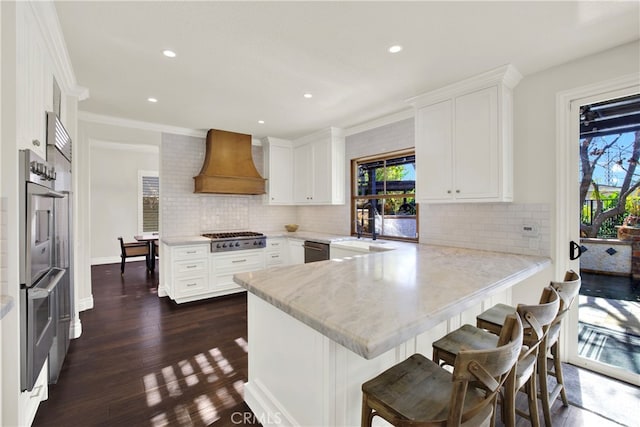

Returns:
553,73,640,385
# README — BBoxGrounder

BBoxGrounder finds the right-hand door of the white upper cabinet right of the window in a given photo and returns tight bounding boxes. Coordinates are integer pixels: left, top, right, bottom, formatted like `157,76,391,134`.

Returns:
454,87,500,199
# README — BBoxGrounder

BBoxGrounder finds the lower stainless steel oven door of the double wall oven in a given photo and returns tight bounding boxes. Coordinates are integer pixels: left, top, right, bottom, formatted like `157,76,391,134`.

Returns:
20,268,65,391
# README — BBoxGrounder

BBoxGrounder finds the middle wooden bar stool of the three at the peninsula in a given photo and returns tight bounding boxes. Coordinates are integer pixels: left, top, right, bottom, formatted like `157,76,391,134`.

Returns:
433,286,560,427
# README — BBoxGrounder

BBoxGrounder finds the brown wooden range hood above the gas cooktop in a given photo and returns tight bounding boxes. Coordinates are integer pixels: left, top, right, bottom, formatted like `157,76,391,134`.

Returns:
193,129,265,194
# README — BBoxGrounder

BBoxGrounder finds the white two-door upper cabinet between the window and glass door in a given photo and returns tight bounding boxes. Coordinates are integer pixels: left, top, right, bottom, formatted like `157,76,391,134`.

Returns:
409,65,522,203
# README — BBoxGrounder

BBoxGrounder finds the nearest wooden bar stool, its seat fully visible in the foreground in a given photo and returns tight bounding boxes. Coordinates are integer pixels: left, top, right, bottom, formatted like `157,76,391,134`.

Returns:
361,315,523,427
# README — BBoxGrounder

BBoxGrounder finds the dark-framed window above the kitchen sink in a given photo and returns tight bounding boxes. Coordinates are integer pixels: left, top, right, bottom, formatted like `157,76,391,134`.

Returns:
351,150,418,242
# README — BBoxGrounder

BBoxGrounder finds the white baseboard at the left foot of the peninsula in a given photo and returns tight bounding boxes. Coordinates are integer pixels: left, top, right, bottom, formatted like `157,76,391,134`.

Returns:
244,380,300,426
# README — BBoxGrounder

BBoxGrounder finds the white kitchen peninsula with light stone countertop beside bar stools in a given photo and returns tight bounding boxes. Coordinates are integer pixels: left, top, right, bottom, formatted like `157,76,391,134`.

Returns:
234,245,550,426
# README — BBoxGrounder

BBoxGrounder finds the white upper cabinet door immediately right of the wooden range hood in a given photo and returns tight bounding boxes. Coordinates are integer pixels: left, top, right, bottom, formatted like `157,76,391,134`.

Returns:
267,144,293,205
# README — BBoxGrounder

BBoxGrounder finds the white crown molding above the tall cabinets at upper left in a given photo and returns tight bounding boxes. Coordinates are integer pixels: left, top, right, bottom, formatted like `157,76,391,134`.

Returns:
26,0,89,101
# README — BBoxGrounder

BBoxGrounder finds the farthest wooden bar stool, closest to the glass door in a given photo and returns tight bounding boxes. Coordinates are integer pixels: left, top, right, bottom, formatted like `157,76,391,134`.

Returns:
476,270,582,427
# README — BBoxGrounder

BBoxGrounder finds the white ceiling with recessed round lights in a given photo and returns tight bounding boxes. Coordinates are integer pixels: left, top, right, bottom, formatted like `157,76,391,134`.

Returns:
55,1,640,138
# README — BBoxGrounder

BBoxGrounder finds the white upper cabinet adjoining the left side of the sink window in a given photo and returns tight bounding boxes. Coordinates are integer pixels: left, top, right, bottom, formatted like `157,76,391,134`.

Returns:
293,128,345,205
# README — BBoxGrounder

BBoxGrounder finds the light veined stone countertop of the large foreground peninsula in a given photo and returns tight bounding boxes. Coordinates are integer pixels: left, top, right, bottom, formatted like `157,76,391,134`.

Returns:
234,244,551,359
